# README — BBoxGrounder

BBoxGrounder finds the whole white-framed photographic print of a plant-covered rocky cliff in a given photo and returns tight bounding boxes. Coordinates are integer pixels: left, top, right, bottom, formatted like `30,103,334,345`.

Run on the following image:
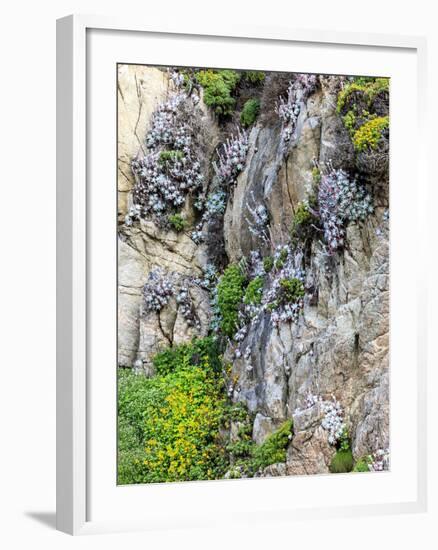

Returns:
57,16,426,534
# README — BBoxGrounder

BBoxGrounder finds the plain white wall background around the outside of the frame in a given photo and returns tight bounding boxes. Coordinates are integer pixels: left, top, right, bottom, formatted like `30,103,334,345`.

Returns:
0,0,438,550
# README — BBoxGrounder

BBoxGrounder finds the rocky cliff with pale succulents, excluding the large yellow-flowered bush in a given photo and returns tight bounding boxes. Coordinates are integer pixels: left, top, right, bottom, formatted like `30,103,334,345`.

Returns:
118,66,389,475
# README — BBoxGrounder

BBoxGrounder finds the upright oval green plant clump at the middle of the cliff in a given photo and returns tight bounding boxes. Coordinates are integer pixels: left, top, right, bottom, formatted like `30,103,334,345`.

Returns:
217,264,245,338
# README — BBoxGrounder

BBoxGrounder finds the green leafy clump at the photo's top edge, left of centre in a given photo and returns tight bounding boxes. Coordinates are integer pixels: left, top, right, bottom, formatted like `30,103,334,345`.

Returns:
196,69,240,116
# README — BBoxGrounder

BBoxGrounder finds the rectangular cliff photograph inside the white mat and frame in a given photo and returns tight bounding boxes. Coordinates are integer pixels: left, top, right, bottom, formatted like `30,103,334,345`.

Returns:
117,63,391,485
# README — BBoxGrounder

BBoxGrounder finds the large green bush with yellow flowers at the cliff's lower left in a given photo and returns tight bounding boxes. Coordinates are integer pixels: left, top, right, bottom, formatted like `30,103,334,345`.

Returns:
118,343,226,484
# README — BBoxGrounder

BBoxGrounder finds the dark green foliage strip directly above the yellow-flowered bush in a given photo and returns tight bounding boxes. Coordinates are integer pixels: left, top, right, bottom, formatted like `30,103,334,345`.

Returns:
152,336,222,376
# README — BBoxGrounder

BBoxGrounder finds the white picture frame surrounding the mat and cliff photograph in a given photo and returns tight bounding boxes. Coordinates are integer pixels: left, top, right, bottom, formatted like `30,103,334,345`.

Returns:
57,15,427,534
